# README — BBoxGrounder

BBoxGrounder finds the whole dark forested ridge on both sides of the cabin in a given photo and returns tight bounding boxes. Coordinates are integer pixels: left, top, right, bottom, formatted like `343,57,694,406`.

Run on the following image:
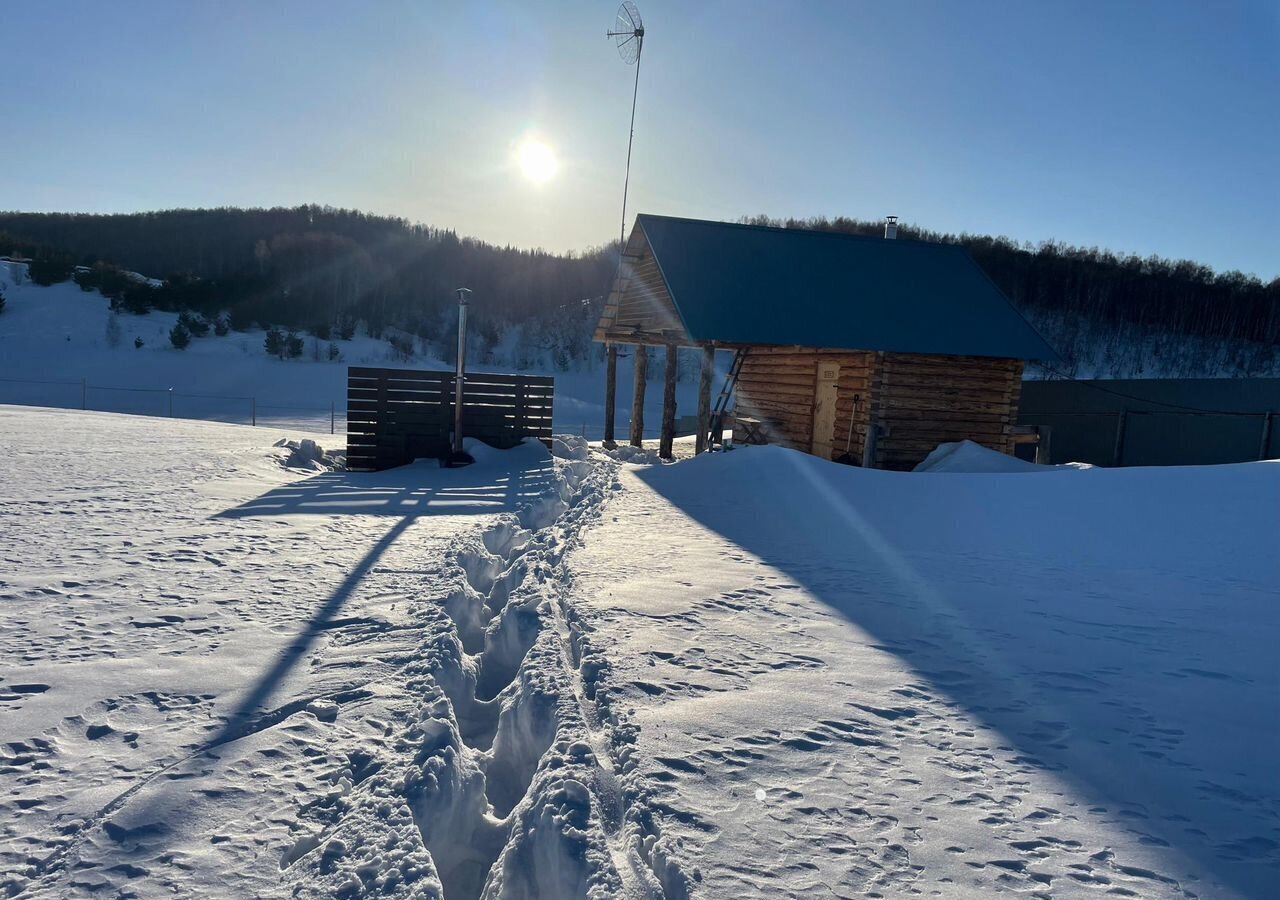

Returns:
0,206,1280,376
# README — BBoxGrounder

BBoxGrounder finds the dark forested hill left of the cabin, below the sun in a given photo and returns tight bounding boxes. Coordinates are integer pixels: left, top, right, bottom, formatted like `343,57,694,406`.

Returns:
0,206,617,367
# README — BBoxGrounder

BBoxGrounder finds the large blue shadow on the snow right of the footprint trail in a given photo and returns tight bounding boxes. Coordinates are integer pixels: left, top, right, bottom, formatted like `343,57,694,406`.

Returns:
637,448,1280,896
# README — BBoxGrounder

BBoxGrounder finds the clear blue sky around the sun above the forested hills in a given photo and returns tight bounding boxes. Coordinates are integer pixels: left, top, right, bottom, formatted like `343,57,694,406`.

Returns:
10,0,1280,279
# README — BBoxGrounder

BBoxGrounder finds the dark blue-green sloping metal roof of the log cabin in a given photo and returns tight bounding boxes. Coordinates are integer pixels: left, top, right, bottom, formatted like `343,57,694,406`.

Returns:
636,214,1057,360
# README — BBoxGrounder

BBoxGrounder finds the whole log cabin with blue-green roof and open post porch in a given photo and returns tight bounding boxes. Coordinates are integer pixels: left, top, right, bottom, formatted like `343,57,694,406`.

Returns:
595,214,1057,470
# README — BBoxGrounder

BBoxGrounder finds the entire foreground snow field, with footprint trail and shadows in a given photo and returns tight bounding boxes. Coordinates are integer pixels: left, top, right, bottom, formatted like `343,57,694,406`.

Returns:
0,407,1280,900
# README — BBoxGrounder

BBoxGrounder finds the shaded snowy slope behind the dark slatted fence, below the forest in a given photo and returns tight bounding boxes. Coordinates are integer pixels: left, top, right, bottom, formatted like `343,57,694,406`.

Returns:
0,262,696,437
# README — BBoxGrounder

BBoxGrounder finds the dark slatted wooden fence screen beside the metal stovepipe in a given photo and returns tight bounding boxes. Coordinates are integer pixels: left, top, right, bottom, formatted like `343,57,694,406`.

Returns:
347,366,556,471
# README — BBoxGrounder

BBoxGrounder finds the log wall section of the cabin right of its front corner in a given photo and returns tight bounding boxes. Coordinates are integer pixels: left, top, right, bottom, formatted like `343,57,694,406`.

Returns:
872,353,1023,470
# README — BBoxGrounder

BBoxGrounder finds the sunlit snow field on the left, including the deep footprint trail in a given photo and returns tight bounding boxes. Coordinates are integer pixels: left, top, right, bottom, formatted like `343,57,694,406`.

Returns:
0,407,617,900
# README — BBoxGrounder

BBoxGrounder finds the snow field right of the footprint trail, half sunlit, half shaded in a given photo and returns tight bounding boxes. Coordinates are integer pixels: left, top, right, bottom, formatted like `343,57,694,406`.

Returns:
568,448,1280,897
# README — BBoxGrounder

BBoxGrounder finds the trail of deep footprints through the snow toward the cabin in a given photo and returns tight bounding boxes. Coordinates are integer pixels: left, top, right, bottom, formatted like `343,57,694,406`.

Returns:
289,440,687,900
